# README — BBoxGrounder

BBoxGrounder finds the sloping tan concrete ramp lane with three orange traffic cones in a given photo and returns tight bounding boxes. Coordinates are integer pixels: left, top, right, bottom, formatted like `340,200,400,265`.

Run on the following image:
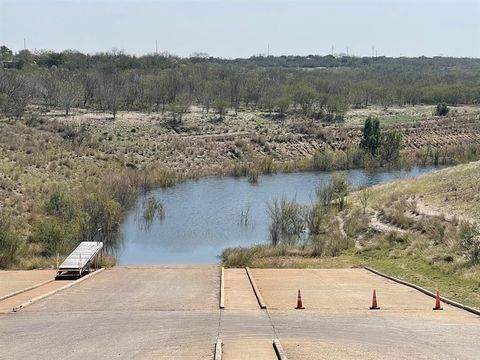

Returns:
252,269,474,321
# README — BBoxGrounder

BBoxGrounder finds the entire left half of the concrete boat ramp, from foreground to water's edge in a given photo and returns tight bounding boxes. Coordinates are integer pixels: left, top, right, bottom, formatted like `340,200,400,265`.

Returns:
0,266,220,360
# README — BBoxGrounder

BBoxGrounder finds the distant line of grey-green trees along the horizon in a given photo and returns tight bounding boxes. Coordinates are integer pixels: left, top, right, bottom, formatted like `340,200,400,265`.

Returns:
0,46,480,122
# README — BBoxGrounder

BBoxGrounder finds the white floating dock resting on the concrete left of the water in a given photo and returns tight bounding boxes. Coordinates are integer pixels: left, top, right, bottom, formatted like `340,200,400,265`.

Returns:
57,241,103,276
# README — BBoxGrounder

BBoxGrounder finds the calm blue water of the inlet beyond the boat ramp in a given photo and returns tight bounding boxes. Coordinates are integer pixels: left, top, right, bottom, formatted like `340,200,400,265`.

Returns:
117,167,435,265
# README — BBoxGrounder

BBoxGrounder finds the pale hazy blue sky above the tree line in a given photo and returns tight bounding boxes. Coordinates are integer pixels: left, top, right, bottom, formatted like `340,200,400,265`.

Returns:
0,0,480,58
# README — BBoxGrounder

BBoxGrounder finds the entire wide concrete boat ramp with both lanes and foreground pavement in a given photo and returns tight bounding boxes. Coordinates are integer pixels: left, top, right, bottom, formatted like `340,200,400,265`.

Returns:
0,266,480,360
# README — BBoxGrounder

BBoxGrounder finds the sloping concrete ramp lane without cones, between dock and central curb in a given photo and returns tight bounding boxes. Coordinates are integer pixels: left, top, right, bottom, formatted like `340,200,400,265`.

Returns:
22,266,220,312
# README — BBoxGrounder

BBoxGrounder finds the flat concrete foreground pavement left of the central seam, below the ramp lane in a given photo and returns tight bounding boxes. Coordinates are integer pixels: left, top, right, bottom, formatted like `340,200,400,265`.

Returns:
0,310,219,360
